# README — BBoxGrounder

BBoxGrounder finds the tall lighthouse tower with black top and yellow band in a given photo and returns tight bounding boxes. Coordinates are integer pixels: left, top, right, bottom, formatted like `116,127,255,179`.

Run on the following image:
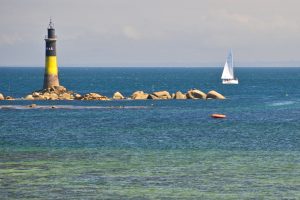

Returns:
43,19,59,89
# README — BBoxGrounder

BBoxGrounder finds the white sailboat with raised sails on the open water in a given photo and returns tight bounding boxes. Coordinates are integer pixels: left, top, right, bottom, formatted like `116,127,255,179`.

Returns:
221,50,239,84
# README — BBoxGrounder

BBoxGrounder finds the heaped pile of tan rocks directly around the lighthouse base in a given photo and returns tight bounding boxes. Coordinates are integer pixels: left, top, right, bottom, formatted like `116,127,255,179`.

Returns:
25,86,81,100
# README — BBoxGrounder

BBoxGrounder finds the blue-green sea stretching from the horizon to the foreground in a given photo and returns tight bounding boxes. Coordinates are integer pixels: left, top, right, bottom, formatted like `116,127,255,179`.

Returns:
0,67,300,200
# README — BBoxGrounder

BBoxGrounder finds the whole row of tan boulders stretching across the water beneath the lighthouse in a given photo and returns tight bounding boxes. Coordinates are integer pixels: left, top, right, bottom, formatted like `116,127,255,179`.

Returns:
0,86,226,101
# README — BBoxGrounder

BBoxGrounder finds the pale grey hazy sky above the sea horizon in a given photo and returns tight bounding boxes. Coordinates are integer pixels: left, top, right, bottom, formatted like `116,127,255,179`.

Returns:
0,0,300,67
